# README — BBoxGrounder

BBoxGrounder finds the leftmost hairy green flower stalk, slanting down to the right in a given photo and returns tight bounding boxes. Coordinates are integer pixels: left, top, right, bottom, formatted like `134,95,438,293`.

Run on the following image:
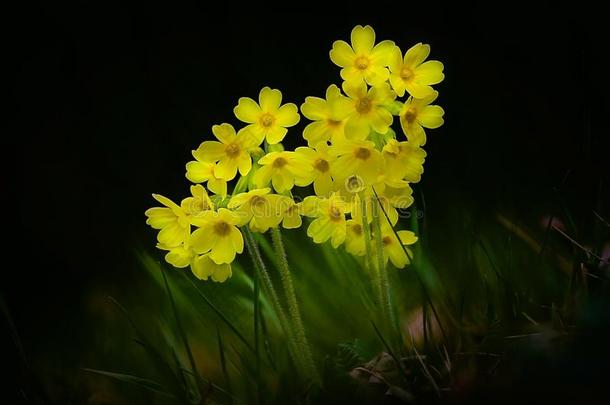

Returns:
242,225,306,376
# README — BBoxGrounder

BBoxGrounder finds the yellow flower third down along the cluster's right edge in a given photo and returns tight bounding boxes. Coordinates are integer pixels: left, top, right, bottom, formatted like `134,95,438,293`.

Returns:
382,139,426,186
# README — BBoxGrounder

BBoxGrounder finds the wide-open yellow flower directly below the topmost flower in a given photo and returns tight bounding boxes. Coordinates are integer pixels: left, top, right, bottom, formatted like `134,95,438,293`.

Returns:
343,82,396,140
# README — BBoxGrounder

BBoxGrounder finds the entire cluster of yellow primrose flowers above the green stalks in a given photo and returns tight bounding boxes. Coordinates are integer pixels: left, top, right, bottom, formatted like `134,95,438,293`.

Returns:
146,26,444,282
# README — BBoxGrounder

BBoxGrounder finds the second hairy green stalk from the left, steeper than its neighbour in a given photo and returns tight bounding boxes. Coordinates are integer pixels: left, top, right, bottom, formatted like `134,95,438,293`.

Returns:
271,228,320,383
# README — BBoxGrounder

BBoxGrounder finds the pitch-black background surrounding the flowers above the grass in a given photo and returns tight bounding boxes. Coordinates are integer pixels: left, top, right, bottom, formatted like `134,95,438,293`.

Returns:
0,2,608,400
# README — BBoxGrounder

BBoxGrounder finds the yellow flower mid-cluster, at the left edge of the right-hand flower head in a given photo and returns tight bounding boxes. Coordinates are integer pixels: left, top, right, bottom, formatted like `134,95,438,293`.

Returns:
294,142,335,197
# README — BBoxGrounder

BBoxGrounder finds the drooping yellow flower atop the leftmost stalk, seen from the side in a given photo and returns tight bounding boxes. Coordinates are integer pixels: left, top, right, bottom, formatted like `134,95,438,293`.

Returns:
227,187,289,232
